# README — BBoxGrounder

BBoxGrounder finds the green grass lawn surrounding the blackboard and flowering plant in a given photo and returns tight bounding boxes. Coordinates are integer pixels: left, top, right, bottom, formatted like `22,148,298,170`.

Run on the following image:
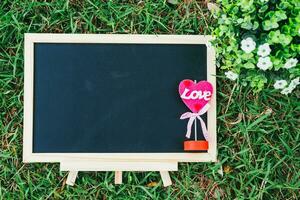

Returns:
0,0,300,199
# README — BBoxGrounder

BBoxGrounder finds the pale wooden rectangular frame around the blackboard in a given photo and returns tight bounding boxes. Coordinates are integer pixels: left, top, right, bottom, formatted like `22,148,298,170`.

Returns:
23,33,217,163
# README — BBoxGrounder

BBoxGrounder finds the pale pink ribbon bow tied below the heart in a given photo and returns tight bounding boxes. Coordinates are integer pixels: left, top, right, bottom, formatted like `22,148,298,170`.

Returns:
180,104,210,140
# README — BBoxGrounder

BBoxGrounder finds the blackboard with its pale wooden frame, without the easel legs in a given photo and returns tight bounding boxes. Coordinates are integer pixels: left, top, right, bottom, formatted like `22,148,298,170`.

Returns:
23,34,216,162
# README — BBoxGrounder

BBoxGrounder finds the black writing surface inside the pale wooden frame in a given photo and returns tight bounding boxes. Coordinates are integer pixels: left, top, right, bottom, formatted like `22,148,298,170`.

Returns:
33,43,207,153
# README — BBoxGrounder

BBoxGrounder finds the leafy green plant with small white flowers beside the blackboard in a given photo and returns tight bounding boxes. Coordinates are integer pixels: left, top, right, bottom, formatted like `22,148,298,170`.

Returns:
213,0,300,95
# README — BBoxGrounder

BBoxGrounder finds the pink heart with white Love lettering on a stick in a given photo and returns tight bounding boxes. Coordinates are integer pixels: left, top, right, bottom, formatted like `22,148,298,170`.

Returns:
179,79,213,113
